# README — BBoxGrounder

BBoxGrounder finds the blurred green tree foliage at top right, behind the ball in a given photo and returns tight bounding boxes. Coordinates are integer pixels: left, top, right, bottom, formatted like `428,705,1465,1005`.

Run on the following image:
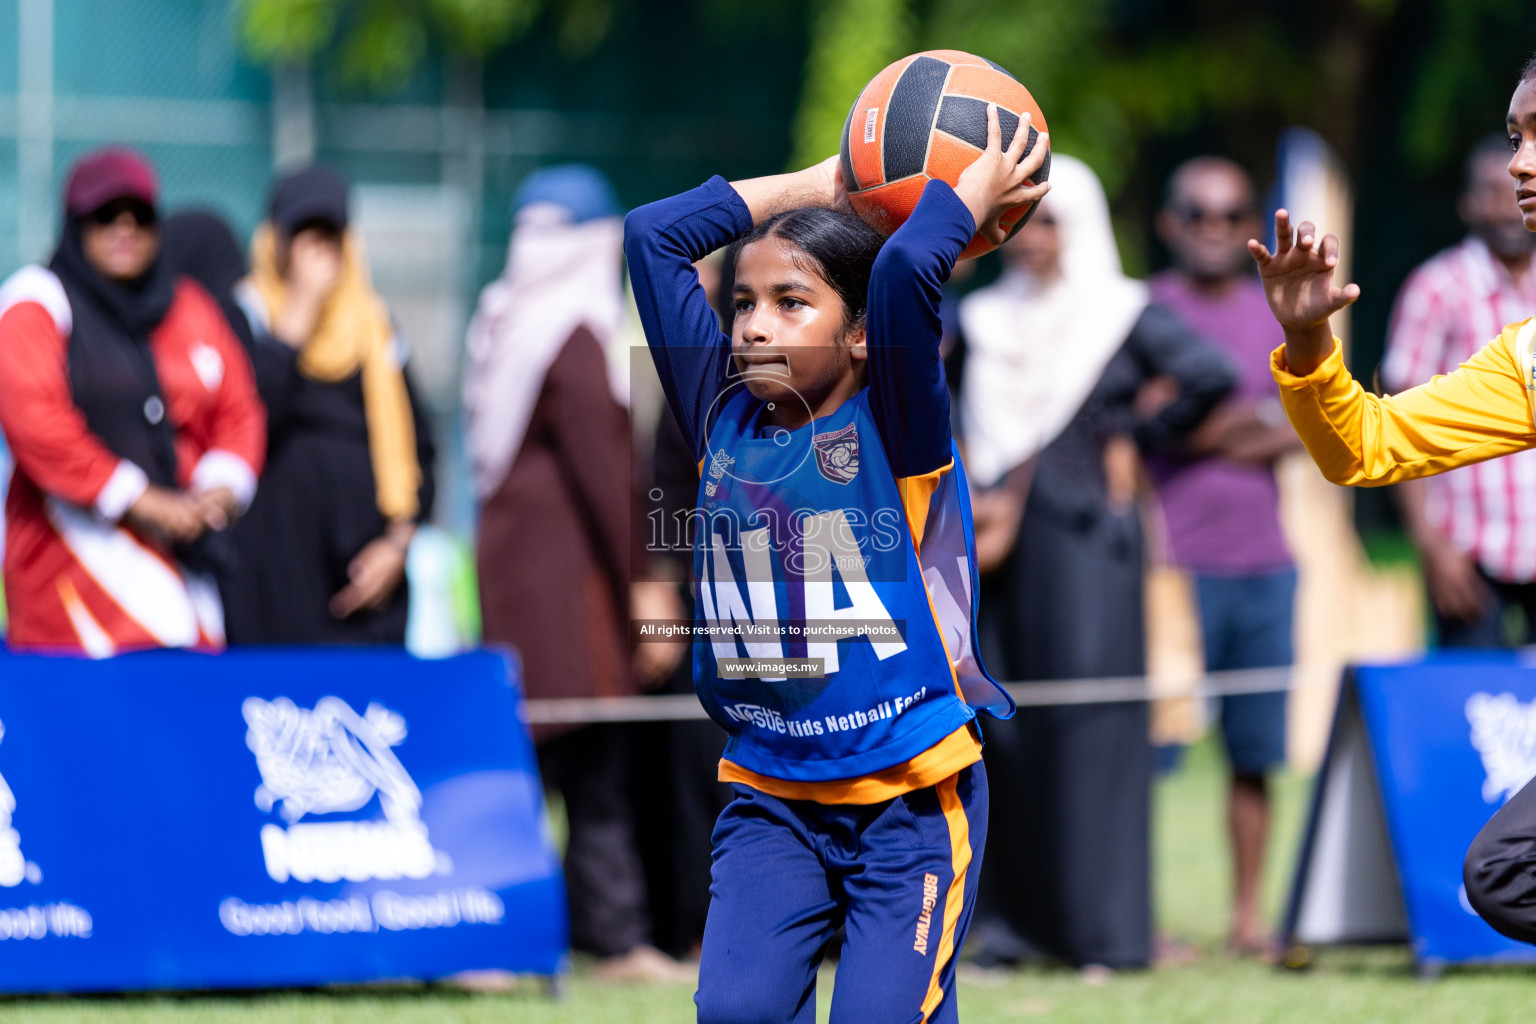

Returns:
793,0,1536,195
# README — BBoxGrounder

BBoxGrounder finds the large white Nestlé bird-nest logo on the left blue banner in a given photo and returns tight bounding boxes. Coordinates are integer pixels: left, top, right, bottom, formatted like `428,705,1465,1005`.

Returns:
241,697,452,881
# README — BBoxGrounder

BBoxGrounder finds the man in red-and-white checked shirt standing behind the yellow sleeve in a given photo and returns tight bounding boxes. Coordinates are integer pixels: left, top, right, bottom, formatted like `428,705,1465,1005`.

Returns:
1381,135,1536,648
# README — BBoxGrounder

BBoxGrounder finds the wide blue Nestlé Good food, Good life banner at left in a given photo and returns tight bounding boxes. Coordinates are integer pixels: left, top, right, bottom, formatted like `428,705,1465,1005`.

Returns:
0,649,567,992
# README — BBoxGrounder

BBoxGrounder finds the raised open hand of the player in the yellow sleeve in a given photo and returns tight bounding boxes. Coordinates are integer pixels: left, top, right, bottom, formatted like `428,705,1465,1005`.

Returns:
1249,210,1359,376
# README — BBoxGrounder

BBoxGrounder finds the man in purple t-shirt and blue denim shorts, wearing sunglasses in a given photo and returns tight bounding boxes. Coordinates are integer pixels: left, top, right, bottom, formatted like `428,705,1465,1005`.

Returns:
1149,157,1301,955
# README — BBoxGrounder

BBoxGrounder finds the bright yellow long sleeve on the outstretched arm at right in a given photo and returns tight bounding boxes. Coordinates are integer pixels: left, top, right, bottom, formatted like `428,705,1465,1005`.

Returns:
1270,321,1536,487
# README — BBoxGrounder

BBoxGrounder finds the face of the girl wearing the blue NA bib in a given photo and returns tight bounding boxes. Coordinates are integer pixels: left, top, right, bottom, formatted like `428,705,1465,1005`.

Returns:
731,238,868,430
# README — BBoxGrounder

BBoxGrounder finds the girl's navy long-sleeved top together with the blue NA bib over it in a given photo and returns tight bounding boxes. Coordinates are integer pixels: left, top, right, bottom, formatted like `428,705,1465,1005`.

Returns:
625,178,1012,803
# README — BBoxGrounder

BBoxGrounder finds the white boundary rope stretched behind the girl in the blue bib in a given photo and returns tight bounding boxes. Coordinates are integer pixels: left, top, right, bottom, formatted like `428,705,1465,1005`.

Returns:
522,665,1339,725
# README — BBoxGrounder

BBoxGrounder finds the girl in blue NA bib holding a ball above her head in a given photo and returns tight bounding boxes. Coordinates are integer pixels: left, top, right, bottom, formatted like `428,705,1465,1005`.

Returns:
625,109,1048,1024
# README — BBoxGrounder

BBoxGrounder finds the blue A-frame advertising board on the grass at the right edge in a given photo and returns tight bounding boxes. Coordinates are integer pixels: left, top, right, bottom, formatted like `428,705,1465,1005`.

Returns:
1286,652,1536,973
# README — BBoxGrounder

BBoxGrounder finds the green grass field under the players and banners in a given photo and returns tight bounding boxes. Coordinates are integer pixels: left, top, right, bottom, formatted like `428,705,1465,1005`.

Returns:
0,746,1536,1024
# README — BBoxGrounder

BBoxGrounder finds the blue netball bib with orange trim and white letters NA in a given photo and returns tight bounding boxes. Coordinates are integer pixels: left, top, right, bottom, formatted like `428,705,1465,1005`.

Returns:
687,381,1012,781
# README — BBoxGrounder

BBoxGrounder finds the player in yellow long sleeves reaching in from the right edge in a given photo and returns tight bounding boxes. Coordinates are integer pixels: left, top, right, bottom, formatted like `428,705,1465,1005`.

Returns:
1249,58,1536,943
